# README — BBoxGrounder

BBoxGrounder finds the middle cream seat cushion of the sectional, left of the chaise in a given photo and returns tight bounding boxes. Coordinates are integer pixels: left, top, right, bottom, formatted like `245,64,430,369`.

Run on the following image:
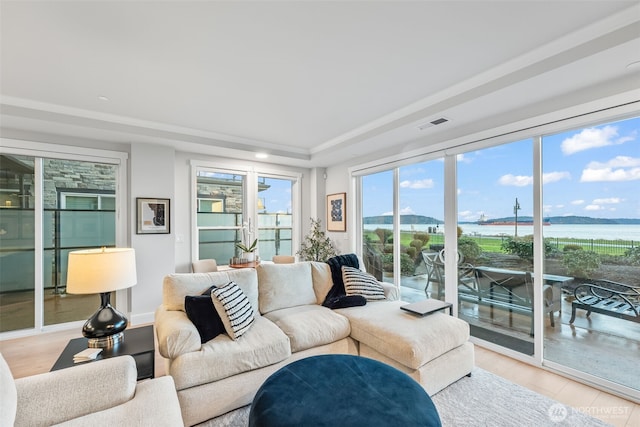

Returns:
264,304,351,353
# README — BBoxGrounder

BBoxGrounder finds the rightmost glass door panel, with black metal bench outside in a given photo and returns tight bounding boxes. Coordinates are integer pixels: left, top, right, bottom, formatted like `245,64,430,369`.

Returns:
542,118,640,390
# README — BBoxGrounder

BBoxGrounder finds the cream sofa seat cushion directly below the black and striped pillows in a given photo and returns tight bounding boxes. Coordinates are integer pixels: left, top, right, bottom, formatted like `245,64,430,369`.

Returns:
169,316,291,390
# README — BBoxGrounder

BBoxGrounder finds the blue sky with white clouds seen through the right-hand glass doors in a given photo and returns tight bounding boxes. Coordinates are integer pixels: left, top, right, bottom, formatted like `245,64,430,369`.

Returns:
363,114,640,221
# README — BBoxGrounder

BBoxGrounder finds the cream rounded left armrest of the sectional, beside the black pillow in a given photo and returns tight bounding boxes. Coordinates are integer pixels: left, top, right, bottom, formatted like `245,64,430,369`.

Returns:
155,305,202,360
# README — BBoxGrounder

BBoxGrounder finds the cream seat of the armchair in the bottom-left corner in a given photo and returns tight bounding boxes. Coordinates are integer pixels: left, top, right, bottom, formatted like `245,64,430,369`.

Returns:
55,376,184,427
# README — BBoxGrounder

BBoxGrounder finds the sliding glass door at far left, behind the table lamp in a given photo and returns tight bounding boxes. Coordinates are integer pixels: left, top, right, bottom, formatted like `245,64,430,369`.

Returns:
0,147,126,332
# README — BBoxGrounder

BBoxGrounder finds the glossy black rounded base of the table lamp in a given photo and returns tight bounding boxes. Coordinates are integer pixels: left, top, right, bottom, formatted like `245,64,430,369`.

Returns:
82,292,128,348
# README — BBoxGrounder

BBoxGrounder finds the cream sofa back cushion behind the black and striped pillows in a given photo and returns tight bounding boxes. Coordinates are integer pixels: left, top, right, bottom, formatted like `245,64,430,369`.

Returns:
162,268,258,315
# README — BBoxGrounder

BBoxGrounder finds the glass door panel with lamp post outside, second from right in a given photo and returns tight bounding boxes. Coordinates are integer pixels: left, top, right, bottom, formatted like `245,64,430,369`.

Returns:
456,139,535,355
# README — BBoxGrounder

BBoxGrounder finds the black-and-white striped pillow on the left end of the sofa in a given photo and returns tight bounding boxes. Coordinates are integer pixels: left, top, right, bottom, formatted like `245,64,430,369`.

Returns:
211,282,254,341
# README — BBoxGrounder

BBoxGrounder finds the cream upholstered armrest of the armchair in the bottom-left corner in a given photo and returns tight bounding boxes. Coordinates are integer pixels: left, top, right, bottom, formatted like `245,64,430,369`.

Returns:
15,356,138,426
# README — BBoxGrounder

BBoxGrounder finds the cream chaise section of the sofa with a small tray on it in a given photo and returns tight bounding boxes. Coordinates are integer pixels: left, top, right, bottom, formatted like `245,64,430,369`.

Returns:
336,301,469,369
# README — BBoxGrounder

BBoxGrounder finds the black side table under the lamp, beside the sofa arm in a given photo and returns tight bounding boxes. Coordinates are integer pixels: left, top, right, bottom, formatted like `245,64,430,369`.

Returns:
51,325,155,380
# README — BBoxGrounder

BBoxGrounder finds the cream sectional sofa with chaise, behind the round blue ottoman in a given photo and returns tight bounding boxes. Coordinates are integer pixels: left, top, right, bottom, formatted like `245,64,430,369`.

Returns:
155,262,474,425
